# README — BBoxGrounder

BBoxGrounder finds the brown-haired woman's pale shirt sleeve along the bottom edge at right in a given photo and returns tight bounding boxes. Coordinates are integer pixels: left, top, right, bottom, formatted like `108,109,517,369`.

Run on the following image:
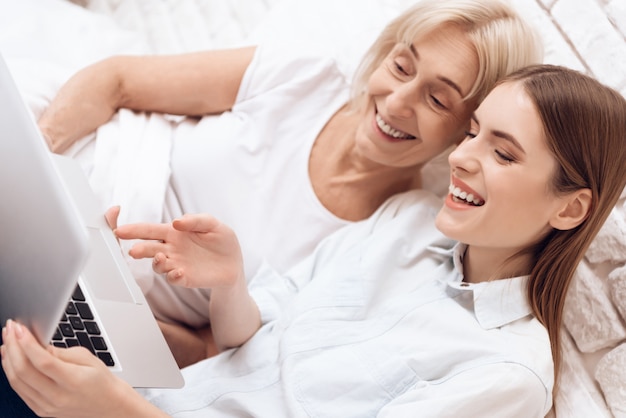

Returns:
378,363,552,418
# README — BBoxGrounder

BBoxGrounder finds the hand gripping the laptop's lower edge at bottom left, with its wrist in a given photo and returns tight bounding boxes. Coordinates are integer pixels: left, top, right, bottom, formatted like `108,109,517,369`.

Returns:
1,320,165,418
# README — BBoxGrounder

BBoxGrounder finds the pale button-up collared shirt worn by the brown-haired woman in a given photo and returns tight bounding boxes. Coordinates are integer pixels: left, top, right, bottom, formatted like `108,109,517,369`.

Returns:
145,191,553,418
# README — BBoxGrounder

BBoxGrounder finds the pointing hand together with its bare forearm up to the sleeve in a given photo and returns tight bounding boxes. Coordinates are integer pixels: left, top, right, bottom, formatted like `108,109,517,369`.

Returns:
115,214,261,349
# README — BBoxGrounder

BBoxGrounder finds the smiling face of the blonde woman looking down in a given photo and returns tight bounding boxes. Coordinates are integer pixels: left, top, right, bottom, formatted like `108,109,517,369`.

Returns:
356,26,478,167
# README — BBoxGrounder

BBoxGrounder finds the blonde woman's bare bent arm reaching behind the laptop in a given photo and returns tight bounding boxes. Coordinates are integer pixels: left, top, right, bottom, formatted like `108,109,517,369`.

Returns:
39,47,255,152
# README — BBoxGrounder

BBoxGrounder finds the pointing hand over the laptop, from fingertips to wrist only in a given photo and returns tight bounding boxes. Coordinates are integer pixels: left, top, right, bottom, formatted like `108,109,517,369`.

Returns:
115,214,244,288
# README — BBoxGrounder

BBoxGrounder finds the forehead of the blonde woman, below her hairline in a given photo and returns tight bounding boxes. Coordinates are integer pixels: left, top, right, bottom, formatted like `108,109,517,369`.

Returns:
411,26,479,97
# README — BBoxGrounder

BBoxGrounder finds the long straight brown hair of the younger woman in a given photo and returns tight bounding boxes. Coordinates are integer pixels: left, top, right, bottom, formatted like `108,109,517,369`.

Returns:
504,65,626,393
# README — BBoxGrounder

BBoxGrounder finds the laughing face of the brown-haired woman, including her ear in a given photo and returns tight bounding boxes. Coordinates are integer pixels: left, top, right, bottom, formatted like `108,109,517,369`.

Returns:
436,83,566,280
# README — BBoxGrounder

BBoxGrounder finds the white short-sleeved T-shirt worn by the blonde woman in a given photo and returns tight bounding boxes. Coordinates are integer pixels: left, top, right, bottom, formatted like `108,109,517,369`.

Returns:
144,46,349,326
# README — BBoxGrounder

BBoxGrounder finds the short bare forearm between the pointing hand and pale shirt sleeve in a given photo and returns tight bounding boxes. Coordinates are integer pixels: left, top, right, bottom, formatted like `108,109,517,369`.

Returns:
209,280,261,350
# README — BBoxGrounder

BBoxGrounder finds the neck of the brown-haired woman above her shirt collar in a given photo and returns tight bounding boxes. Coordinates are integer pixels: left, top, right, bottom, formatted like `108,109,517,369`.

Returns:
463,246,531,283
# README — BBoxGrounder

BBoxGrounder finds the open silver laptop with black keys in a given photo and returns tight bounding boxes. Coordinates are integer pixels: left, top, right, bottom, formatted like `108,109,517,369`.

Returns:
0,56,184,388
